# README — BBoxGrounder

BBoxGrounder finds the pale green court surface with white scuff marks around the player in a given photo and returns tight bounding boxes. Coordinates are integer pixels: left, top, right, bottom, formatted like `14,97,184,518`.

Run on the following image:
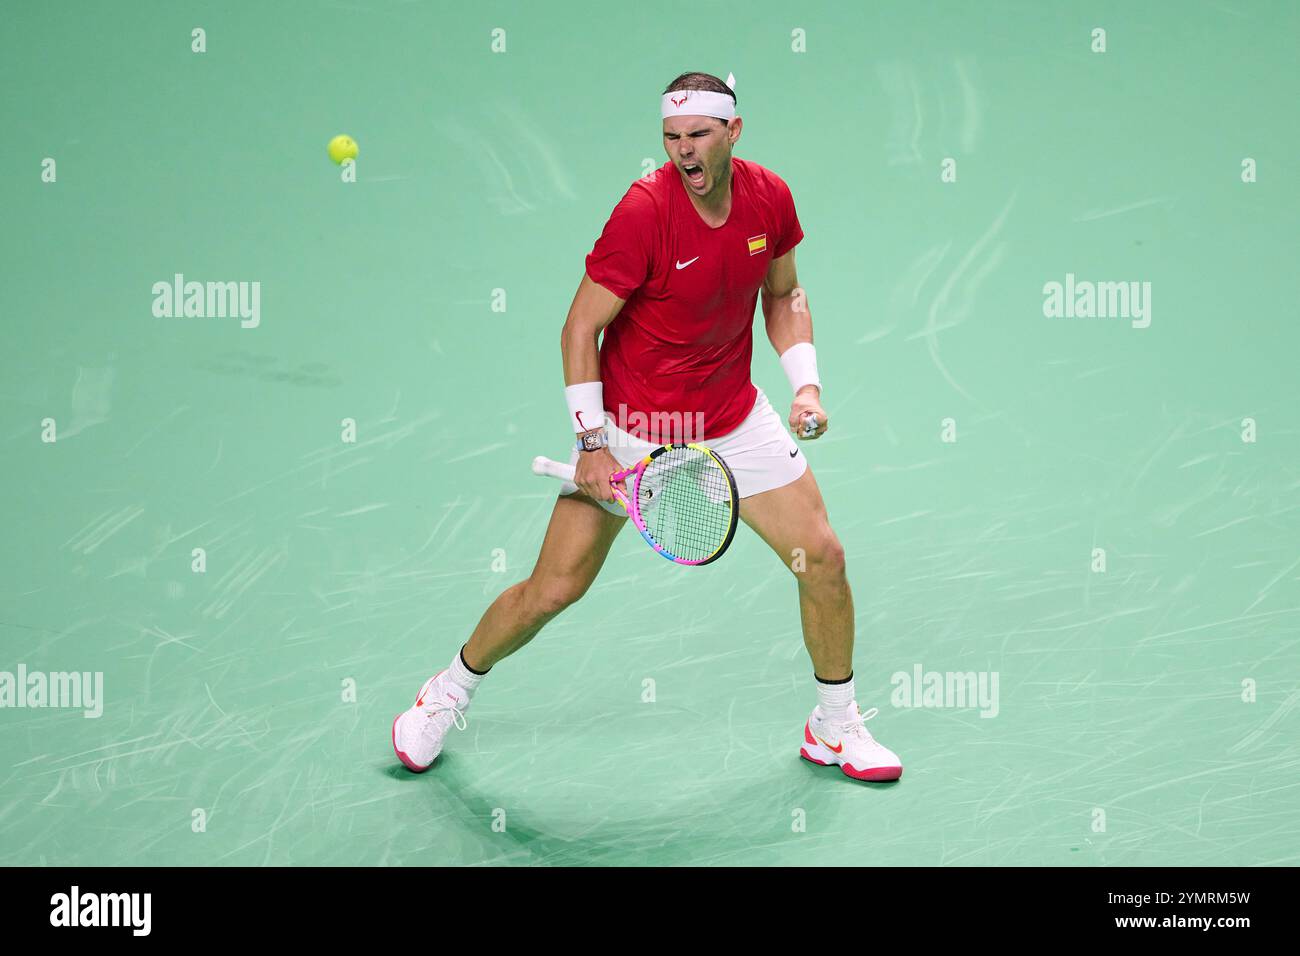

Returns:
0,0,1300,866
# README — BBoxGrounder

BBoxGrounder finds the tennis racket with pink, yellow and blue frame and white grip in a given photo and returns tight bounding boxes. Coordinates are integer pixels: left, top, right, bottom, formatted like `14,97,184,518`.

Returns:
533,442,740,566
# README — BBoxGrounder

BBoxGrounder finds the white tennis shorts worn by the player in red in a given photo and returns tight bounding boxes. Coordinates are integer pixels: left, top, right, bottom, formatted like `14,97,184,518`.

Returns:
560,389,809,515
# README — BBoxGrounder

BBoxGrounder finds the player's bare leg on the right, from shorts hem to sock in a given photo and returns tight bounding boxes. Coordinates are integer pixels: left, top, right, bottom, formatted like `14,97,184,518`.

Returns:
740,468,853,680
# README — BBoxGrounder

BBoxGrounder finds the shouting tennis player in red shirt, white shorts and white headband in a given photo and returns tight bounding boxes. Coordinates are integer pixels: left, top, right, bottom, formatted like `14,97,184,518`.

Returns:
393,73,902,780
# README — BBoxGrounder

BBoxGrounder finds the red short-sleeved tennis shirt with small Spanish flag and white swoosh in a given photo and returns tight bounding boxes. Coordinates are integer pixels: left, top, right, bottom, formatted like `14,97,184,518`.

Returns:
586,156,803,444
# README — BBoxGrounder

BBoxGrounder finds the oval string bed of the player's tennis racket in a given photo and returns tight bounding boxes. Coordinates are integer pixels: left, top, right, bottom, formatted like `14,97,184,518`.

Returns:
637,447,735,561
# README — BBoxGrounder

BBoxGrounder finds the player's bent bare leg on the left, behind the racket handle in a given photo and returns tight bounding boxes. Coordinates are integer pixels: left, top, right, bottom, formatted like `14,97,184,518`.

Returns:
463,492,628,671
